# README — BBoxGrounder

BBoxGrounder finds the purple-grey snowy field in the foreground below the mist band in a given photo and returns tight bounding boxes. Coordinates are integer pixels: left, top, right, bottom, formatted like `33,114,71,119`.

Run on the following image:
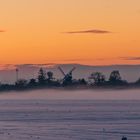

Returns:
0,99,140,140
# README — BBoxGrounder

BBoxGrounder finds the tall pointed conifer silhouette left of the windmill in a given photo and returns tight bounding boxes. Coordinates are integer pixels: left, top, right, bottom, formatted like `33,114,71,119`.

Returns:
38,68,47,86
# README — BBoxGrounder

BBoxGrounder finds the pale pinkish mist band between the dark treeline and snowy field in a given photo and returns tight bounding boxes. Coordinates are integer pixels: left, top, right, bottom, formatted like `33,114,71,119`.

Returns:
0,90,140,100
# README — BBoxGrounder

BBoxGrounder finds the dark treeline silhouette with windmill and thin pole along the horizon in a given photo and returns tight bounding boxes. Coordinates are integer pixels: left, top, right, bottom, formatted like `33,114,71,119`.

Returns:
0,67,140,91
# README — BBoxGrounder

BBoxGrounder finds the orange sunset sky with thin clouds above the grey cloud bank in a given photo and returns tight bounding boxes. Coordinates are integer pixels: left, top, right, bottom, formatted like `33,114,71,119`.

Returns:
0,0,140,65
